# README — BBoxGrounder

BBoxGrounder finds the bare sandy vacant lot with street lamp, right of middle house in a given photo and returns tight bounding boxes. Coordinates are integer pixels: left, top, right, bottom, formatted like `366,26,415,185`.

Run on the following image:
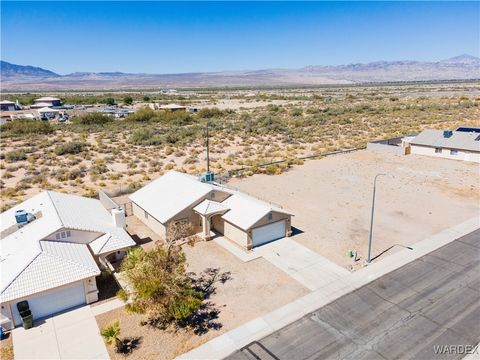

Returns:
229,150,480,269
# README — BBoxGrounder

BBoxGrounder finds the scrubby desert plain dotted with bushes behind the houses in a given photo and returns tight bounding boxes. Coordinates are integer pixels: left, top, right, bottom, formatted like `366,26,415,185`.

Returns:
0,82,480,211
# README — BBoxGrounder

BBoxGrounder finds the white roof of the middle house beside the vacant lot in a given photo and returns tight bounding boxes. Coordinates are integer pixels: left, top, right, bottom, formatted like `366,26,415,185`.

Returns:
130,171,291,230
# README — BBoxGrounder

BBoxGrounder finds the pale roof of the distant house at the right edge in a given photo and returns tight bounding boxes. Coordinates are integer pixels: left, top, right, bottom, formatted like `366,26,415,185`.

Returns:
410,130,480,152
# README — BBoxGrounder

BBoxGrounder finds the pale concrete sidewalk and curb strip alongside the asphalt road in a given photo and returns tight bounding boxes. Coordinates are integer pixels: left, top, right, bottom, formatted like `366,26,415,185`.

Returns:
177,217,480,360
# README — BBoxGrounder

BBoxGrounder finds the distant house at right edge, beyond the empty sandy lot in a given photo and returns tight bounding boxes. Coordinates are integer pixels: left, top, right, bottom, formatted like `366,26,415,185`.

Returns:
410,130,480,163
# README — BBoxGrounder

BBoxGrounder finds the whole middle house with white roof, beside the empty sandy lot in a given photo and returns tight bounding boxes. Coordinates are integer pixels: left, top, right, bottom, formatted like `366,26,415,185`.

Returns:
130,171,292,249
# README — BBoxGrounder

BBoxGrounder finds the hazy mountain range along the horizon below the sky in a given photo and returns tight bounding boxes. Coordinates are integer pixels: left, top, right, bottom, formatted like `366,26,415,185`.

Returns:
0,55,480,91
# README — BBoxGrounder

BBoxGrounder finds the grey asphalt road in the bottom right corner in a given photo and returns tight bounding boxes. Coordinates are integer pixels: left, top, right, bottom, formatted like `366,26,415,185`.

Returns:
227,229,480,360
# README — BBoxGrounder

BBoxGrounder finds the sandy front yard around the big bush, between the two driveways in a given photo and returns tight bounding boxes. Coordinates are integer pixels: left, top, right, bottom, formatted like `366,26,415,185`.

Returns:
97,242,308,359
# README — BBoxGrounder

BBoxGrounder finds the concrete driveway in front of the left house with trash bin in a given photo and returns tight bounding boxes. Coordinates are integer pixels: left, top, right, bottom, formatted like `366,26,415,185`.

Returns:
13,305,110,360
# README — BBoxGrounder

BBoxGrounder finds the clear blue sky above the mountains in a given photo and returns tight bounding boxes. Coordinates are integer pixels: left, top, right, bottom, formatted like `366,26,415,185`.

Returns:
1,1,480,74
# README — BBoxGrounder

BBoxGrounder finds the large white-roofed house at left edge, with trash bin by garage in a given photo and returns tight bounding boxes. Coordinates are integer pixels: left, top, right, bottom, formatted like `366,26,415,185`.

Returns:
0,191,135,329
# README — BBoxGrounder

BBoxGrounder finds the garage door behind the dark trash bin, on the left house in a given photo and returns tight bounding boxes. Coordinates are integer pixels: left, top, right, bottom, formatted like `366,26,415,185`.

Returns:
12,283,85,326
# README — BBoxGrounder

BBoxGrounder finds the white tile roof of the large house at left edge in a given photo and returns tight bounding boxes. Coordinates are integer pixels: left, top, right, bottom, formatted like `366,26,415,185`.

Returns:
0,191,135,301
